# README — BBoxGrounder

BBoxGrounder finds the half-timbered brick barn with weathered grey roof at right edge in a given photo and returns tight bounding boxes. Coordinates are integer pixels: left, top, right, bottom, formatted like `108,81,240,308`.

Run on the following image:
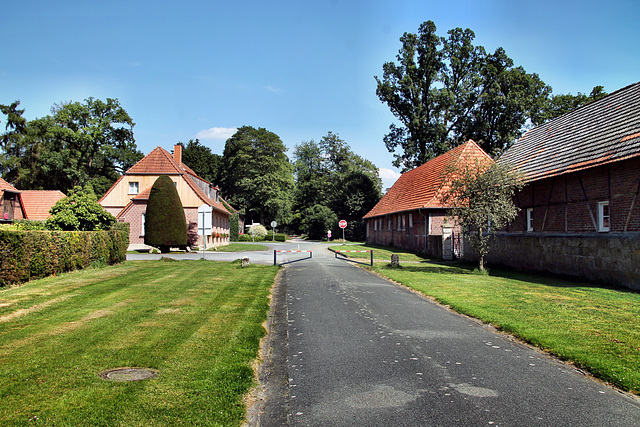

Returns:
476,82,640,289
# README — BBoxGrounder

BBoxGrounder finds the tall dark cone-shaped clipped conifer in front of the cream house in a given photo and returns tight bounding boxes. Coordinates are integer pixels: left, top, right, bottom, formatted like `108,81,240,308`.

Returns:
144,175,187,253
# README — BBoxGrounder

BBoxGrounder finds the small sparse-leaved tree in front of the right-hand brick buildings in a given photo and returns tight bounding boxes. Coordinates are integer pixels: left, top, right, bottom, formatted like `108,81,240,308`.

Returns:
443,163,524,271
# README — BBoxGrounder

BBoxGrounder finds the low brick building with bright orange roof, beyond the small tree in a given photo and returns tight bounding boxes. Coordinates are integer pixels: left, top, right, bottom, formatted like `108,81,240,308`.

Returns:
364,140,493,258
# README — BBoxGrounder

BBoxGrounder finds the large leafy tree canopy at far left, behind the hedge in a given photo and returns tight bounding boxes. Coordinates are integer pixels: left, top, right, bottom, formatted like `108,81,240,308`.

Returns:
0,98,142,194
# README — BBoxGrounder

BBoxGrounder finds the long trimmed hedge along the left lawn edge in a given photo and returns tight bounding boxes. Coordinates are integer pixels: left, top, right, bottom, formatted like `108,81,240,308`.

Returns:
0,227,129,287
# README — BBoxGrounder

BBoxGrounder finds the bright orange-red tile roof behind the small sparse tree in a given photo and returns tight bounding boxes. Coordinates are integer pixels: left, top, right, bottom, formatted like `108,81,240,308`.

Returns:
364,140,493,218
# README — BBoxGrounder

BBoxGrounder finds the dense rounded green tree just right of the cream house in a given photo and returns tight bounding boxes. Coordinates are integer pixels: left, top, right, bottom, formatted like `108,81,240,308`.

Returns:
221,126,294,224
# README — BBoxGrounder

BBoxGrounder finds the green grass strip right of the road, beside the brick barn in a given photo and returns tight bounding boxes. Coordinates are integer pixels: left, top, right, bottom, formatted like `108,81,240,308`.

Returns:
373,264,640,394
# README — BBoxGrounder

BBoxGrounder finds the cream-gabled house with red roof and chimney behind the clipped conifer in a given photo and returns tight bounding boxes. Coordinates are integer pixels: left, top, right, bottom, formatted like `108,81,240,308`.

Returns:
99,144,231,248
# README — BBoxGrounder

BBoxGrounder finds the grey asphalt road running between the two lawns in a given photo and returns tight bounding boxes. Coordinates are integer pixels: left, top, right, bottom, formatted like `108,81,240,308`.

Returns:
252,244,640,426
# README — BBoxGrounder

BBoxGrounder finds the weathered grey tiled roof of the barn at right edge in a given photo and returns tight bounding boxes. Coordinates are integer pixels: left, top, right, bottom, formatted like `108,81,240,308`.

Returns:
499,82,640,181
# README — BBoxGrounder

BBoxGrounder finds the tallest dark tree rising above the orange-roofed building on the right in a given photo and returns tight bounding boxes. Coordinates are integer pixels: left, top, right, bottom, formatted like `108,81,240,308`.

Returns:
375,21,550,170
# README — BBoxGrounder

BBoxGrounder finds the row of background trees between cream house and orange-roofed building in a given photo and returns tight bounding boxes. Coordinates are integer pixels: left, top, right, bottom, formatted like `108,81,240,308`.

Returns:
182,126,382,239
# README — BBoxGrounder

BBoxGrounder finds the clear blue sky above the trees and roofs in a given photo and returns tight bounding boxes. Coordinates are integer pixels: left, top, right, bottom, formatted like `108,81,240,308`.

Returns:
0,0,640,187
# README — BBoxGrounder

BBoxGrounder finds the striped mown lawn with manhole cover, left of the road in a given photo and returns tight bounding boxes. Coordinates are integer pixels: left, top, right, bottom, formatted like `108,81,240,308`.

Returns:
0,261,278,426
